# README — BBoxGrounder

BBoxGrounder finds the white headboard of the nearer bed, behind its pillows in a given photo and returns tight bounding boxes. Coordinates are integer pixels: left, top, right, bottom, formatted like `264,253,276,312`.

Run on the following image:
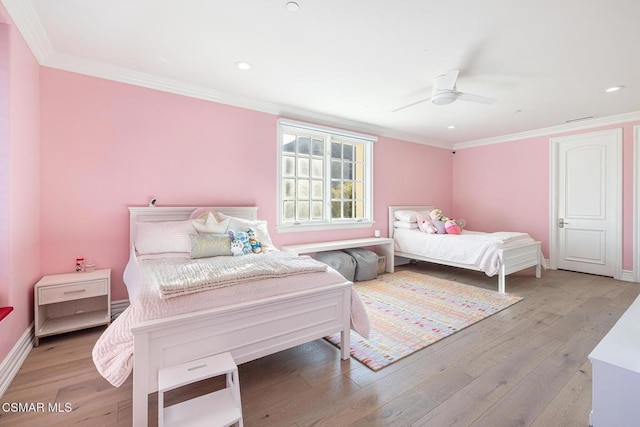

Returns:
129,206,258,247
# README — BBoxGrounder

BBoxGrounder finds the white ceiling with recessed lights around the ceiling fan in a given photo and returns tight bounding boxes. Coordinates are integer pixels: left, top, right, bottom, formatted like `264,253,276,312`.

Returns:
1,0,640,147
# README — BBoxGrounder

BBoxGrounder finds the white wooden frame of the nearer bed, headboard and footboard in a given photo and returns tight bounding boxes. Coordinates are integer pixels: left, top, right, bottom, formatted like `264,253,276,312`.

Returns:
129,207,352,427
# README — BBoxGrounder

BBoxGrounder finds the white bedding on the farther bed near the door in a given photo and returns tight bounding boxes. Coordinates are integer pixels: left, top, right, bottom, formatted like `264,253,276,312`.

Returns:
393,228,535,276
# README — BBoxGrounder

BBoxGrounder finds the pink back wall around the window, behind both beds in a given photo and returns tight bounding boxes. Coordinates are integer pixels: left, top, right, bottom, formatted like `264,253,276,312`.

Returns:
40,68,452,300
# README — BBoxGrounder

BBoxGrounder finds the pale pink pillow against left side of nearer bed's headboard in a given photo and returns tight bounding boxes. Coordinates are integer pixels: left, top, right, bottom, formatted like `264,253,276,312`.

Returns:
134,220,196,255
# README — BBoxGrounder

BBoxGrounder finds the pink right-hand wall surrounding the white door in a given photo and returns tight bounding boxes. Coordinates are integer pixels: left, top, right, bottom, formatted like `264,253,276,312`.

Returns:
453,123,638,270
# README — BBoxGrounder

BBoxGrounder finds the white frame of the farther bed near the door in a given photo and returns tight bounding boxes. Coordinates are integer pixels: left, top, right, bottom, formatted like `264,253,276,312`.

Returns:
389,206,542,293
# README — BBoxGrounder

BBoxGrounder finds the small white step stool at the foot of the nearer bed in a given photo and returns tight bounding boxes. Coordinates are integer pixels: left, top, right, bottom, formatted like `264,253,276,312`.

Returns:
158,353,243,427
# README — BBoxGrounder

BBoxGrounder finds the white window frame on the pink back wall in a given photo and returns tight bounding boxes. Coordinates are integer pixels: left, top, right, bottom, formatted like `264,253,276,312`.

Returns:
276,118,378,233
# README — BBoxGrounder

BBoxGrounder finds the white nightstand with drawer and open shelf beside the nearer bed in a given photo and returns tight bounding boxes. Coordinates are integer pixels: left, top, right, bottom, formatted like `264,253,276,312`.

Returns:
34,269,111,347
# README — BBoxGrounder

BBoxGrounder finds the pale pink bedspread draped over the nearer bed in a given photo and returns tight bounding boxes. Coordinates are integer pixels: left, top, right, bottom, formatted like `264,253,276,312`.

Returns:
93,251,369,386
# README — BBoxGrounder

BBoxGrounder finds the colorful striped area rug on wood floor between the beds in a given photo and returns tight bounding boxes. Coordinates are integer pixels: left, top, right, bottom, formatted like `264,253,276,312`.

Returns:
325,271,522,371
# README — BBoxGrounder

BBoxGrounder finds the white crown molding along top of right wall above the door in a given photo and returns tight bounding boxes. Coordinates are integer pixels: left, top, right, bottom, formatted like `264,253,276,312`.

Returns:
453,111,640,150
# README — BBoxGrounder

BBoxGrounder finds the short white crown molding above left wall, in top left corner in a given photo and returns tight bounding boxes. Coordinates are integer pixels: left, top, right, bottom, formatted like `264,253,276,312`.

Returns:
1,0,53,65
